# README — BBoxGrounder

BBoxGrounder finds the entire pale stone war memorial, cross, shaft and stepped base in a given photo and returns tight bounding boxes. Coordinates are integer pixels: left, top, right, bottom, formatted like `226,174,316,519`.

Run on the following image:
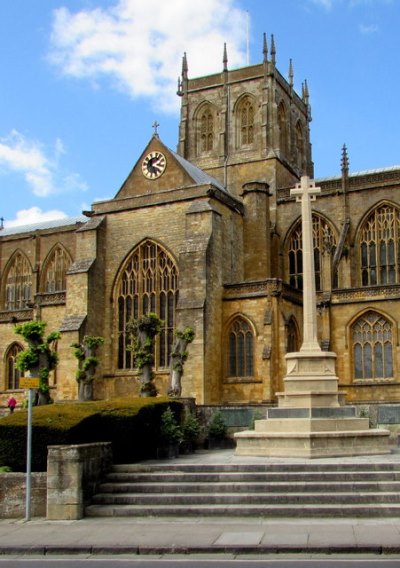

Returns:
235,176,390,458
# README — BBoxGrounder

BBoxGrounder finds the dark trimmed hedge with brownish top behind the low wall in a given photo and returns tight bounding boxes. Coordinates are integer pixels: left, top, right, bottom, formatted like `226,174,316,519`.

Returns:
0,397,182,471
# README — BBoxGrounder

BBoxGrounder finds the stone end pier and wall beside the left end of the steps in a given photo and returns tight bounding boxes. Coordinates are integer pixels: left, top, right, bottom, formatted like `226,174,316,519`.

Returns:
47,442,112,521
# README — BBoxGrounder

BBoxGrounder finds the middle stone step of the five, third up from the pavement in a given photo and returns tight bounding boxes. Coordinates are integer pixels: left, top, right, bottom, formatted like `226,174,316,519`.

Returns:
98,481,400,495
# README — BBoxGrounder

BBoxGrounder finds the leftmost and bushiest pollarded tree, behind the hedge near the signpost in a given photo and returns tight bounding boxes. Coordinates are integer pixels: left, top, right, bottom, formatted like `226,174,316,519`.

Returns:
14,321,60,405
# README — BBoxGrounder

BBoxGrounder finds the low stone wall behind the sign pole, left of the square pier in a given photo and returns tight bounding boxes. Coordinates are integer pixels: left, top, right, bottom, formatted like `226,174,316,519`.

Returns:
0,472,47,519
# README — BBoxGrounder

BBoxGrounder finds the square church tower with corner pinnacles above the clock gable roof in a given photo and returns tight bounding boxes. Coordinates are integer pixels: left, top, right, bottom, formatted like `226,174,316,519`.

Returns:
178,34,313,201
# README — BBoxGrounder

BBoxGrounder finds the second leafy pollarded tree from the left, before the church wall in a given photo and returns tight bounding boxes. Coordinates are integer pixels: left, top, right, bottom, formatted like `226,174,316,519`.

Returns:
71,335,104,400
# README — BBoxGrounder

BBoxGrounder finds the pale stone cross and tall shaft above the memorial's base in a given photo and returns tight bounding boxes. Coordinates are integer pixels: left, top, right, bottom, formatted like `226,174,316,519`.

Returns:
290,176,321,351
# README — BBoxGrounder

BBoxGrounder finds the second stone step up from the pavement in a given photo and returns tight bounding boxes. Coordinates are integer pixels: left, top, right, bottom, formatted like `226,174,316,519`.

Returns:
92,491,400,507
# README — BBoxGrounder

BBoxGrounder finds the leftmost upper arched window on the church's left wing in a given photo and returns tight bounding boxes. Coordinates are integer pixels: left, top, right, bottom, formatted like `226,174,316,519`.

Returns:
4,252,32,310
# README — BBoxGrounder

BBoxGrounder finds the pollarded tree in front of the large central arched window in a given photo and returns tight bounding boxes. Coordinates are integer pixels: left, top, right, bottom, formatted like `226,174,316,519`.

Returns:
126,312,163,396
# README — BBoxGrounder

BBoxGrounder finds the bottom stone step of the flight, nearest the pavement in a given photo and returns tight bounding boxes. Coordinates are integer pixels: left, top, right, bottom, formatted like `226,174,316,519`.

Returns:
86,503,400,518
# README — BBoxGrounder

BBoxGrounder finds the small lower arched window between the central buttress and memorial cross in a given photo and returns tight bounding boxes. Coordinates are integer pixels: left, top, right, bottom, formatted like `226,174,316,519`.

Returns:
228,317,254,377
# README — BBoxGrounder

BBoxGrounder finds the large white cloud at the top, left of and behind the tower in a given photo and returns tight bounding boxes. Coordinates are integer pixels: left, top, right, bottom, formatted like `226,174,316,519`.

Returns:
49,0,246,111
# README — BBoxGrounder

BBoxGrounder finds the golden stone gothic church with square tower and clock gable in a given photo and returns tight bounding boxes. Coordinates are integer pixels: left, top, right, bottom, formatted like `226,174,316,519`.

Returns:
0,37,400,405
